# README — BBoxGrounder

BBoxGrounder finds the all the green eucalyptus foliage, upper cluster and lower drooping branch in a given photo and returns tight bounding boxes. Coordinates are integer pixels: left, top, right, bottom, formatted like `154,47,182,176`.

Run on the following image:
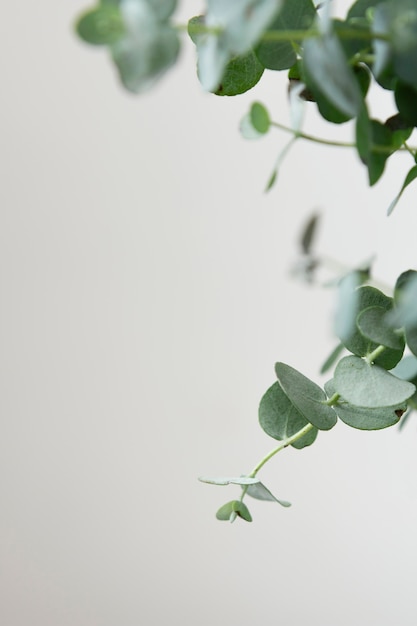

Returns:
76,0,417,521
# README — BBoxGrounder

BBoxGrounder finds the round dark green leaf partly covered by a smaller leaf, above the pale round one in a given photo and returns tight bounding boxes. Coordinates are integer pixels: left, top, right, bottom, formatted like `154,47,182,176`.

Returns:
338,285,403,368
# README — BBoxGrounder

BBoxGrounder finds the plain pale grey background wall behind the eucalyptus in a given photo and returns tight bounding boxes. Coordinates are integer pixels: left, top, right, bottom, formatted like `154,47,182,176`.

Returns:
0,0,417,626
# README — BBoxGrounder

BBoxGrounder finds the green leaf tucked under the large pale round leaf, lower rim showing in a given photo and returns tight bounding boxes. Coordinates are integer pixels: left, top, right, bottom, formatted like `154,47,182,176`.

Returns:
324,381,407,430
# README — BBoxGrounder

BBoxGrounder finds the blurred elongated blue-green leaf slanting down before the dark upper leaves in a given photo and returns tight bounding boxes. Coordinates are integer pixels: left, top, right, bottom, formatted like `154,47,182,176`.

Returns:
303,33,362,117
